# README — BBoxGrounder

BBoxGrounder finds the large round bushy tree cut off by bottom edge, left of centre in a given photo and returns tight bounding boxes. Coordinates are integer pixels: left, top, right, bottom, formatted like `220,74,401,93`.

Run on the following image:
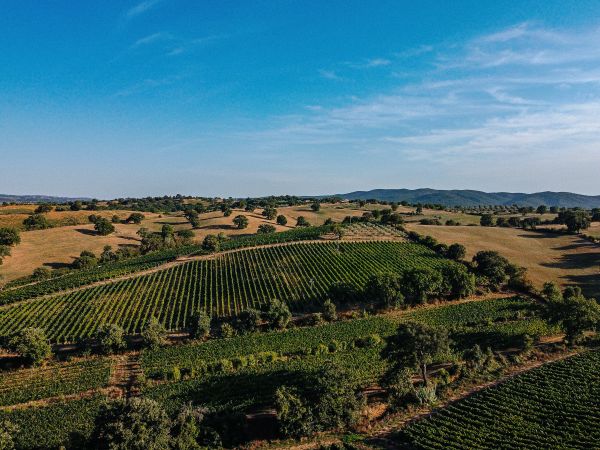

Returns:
95,397,171,450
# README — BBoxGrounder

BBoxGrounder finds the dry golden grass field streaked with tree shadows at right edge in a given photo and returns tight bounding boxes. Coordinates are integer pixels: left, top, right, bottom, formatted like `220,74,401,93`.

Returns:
407,224,600,299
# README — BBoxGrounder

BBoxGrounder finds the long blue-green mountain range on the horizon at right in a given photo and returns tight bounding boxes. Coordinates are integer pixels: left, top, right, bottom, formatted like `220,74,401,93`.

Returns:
338,189,600,208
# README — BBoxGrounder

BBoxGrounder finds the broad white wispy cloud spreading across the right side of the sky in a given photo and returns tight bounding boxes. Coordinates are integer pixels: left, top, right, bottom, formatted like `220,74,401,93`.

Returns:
240,22,600,177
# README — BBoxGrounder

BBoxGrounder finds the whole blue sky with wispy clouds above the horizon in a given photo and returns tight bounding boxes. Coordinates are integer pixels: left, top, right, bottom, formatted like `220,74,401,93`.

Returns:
0,0,600,199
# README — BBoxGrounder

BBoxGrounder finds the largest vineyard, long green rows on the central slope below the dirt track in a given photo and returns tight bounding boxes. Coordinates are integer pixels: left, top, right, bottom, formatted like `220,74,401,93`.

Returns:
0,242,453,342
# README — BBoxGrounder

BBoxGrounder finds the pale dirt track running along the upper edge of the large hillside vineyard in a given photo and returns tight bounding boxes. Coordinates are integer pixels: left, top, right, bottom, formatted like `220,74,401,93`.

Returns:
0,236,406,311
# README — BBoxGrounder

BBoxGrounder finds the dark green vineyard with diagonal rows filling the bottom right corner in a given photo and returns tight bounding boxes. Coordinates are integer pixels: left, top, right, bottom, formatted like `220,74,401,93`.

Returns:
399,350,600,450
